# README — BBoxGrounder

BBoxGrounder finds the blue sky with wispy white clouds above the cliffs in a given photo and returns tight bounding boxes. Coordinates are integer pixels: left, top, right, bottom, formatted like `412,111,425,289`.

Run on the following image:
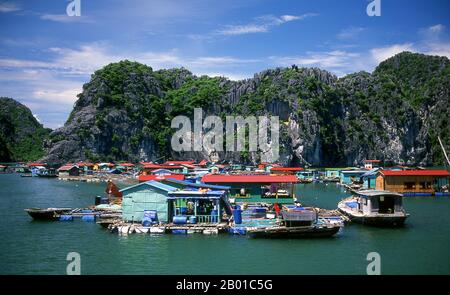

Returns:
0,0,450,128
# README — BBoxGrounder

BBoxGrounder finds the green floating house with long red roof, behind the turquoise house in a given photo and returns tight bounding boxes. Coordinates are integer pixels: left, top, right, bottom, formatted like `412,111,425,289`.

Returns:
202,174,298,204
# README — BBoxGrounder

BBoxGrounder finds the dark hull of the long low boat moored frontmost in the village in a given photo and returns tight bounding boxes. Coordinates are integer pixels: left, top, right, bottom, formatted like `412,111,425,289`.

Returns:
247,226,340,239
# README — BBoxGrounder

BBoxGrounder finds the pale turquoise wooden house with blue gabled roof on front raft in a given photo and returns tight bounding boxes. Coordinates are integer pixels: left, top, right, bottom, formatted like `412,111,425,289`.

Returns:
120,181,177,223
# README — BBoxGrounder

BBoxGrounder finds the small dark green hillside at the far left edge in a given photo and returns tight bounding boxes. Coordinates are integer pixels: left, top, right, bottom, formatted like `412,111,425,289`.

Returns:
0,97,51,162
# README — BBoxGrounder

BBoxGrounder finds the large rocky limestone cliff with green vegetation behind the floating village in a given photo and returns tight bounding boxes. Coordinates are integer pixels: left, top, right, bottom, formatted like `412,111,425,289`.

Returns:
44,52,450,166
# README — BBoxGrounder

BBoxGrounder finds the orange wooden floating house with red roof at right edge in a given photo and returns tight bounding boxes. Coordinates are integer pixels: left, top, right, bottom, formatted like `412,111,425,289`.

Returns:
376,170,450,196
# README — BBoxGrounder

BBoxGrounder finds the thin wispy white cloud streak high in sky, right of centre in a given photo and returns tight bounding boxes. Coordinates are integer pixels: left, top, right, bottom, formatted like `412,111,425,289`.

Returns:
215,13,317,35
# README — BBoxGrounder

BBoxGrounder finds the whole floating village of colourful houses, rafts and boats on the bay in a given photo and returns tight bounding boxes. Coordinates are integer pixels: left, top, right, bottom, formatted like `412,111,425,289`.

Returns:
0,160,450,238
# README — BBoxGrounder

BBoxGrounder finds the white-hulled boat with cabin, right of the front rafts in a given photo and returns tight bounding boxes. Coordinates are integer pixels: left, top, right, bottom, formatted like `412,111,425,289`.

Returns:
338,190,409,226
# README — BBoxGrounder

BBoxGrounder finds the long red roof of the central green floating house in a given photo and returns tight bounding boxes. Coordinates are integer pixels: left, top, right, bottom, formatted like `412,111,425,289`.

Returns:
202,174,298,183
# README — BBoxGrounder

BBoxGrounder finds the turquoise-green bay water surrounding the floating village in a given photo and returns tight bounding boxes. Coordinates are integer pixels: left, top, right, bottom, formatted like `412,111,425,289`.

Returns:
0,174,450,274
